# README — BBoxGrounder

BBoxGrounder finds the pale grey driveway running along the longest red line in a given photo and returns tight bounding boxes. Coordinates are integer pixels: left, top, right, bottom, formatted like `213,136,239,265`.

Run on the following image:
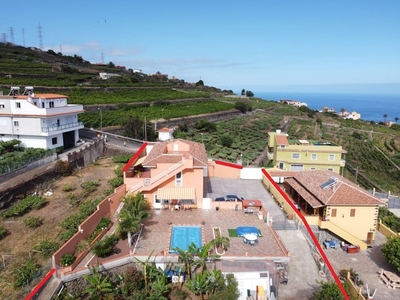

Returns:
204,177,323,300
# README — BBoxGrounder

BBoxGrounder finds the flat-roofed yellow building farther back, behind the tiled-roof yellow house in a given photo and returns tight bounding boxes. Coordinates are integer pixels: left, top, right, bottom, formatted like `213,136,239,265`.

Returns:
268,130,346,174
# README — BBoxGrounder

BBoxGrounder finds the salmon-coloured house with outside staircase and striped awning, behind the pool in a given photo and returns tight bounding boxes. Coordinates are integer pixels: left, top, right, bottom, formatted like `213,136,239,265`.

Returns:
123,139,208,209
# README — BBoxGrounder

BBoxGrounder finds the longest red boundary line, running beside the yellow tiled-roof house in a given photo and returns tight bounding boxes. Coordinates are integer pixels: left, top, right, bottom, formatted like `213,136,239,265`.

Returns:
262,169,350,300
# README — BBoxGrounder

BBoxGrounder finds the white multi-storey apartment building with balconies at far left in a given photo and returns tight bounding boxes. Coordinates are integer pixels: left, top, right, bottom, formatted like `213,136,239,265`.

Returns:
0,87,84,149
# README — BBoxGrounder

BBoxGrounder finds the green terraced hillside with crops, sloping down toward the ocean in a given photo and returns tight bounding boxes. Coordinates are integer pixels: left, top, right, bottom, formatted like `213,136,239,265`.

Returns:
0,44,400,193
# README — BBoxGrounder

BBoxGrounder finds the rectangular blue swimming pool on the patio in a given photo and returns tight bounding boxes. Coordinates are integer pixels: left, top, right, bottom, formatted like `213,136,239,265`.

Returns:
169,226,201,253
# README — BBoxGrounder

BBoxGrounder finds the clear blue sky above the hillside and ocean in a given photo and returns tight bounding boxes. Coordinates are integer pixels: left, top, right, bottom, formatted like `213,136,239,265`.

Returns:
0,0,400,94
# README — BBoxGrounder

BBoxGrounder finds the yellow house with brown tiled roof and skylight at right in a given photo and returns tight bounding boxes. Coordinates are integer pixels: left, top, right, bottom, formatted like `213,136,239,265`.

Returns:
264,170,384,249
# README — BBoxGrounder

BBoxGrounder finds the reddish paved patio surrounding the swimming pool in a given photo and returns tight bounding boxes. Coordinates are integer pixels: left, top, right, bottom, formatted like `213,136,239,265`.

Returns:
135,209,286,258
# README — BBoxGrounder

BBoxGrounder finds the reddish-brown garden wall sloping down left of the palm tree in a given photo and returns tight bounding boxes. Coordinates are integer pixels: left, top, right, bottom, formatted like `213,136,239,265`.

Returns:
52,184,126,273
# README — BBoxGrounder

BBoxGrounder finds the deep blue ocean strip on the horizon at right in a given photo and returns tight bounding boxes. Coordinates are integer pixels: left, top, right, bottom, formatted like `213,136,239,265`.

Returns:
253,92,400,123
